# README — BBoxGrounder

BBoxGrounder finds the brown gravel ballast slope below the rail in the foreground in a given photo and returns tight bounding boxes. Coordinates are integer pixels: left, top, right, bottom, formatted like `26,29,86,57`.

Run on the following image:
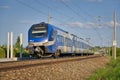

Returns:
0,56,109,80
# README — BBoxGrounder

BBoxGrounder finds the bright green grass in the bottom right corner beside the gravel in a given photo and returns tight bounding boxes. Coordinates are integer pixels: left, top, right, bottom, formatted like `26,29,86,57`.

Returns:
88,57,120,80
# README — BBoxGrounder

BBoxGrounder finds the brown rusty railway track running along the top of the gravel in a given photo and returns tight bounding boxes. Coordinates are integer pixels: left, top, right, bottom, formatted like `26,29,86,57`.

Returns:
0,55,101,72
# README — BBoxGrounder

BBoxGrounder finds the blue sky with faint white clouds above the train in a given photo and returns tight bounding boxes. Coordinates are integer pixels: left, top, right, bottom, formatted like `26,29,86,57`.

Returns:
0,0,120,47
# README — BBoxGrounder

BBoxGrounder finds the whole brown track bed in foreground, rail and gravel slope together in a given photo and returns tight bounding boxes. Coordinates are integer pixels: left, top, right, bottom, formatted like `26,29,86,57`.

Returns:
0,55,109,80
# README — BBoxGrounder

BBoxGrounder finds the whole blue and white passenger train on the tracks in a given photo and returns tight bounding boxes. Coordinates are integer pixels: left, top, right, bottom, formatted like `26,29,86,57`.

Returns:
28,22,93,57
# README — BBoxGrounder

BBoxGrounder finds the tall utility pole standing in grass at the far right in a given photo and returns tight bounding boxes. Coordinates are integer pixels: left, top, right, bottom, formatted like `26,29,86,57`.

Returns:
112,11,117,60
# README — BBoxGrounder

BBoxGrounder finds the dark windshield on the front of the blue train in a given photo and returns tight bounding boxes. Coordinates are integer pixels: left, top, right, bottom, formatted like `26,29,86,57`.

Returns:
31,26,47,38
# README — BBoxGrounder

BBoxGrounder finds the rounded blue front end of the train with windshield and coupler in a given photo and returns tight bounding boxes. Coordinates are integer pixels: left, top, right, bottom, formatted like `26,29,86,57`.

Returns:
28,23,52,57
